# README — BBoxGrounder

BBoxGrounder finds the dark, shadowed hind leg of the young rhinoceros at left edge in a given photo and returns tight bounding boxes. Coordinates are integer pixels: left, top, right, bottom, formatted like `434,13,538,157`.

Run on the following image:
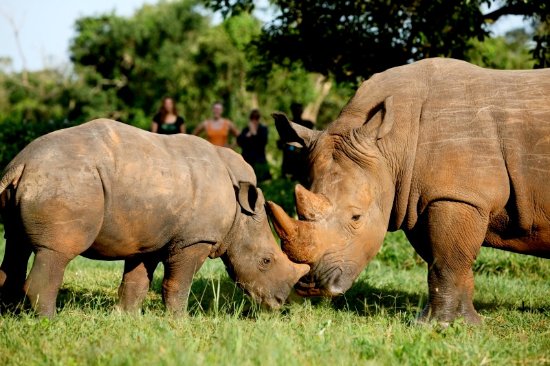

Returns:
0,240,32,310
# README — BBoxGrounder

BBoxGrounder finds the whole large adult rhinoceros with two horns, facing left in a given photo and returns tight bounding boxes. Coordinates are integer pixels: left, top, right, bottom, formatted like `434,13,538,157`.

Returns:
270,59,550,323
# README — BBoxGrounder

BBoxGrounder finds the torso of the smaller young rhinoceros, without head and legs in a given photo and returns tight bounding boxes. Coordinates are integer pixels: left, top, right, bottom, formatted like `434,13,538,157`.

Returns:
3,120,236,258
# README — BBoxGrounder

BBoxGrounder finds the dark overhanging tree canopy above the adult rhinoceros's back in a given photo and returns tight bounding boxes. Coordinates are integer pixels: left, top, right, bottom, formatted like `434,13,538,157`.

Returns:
205,0,550,80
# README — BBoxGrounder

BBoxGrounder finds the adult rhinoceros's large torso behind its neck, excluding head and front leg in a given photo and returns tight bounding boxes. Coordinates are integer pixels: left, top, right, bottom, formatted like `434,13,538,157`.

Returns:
376,59,550,255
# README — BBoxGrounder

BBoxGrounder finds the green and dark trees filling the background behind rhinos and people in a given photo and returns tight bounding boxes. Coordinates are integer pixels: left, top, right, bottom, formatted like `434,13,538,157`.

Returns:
0,0,548,170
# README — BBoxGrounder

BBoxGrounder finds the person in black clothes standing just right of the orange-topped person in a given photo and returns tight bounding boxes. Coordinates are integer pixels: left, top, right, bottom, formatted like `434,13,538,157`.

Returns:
237,109,271,182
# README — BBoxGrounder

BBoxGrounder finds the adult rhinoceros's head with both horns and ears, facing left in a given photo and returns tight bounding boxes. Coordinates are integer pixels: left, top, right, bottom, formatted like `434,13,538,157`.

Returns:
269,106,395,296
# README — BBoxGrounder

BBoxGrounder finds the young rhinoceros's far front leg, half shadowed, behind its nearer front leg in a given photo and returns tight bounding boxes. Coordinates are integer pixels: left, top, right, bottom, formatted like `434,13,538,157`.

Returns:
117,258,159,312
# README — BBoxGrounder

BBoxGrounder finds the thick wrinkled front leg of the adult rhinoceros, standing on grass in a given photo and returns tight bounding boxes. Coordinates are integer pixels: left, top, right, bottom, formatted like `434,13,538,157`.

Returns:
413,201,488,324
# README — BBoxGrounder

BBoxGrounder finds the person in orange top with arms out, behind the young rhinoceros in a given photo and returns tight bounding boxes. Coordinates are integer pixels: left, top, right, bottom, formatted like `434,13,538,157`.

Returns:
193,102,239,147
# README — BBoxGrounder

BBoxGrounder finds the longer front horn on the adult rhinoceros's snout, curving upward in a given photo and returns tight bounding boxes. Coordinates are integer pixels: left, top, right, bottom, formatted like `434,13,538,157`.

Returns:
267,201,318,263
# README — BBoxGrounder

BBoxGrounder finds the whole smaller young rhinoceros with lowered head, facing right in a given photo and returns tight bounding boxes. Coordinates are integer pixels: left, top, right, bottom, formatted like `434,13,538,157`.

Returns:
0,119,309,316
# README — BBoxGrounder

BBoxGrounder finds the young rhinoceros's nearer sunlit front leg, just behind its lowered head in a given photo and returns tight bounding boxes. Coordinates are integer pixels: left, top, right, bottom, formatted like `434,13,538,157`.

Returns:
162,243,212,314
